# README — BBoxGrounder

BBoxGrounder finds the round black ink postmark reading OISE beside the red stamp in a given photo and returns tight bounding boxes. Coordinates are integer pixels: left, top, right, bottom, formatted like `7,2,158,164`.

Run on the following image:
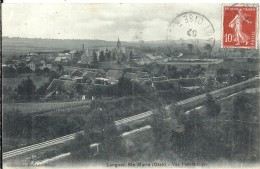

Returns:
166,11,215,55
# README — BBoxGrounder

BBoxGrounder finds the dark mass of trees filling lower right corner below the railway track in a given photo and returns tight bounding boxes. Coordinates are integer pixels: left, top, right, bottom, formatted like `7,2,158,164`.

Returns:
149,95,259,162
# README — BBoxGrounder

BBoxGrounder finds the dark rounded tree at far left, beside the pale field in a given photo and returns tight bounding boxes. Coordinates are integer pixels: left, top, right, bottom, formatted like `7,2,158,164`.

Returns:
15,77,36,101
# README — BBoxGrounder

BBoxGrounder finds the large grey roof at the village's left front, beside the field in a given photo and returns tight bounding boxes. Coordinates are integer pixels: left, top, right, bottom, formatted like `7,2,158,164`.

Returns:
47,79,77,92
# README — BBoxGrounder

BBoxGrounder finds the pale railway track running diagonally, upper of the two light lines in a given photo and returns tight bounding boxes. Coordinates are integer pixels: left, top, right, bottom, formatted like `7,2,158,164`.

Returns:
3,78,259,160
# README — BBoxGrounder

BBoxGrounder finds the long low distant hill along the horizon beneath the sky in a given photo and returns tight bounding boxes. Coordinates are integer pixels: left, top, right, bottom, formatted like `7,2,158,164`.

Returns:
2,37,220,57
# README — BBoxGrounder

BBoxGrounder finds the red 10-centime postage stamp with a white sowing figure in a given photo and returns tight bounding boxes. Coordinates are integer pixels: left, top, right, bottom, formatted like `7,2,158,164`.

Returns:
222,5,258,49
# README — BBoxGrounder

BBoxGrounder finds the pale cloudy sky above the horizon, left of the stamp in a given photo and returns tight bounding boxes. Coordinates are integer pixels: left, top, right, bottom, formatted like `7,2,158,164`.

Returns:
2,4,222,41
